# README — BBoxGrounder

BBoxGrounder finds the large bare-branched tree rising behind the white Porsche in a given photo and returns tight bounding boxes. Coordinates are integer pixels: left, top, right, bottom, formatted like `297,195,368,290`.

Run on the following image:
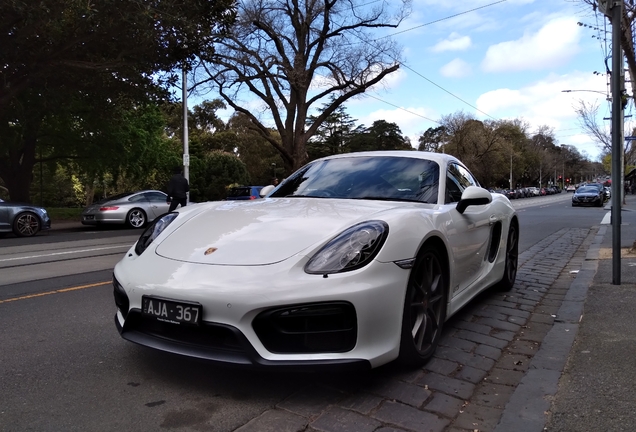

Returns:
200,0,410,176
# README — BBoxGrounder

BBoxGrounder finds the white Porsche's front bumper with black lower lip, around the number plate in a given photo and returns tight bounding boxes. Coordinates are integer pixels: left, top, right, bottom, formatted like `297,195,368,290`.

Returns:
114,254,409,369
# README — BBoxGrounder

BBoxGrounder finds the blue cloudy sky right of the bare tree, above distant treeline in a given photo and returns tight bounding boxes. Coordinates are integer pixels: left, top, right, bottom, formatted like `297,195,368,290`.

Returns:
205,0,620,160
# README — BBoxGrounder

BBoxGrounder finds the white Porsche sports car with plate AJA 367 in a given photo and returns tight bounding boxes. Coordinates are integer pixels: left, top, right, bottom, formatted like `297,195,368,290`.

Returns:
113,151,519,368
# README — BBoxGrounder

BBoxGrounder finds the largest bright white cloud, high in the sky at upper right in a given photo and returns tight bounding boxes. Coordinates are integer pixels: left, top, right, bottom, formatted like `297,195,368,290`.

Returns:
481,17,580,72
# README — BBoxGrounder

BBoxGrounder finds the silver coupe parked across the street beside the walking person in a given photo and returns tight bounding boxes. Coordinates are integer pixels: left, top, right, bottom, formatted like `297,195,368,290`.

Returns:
82,190,170,228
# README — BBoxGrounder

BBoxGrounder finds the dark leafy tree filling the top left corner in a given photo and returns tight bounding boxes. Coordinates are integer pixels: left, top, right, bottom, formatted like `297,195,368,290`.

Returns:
0,0,233,202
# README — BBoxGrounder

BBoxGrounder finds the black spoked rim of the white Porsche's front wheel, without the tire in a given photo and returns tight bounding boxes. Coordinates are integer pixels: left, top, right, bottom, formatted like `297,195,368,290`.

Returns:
409,252,445,354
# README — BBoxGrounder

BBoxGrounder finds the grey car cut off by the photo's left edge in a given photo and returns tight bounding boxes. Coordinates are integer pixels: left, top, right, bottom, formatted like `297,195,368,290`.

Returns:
0,200,51,237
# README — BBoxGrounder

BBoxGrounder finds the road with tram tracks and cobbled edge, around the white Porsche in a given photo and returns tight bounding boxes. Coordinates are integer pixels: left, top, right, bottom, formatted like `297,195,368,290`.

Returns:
0,194,606,432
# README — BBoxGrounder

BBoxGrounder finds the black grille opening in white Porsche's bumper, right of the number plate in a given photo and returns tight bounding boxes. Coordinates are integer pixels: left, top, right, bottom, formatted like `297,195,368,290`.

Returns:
252,302,358,354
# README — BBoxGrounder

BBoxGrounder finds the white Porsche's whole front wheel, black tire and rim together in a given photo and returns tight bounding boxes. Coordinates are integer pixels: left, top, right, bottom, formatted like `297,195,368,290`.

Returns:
398,245,448,366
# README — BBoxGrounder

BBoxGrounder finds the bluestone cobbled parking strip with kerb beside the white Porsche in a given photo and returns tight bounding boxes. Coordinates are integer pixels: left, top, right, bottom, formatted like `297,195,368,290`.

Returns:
231,227,600,432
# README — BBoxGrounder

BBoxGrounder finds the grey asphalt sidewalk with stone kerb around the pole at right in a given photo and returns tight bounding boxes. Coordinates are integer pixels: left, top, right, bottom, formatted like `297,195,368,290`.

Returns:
495,195,636,432
